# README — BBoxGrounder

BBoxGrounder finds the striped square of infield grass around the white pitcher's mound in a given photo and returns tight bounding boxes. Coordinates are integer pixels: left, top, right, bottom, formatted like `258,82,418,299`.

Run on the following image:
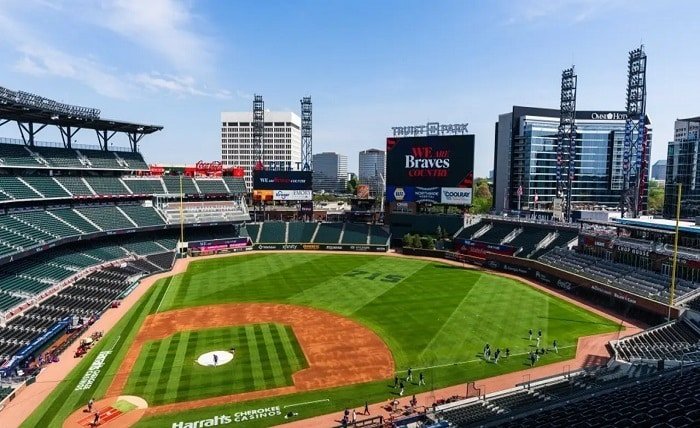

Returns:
124,323,308,405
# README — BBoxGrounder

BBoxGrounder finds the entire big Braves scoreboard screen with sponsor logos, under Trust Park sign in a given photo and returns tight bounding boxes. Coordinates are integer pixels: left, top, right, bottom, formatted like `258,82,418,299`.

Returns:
386,135,474,205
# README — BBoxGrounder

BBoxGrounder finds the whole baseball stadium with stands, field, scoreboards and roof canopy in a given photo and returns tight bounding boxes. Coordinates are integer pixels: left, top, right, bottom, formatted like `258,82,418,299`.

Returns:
0,88,700,428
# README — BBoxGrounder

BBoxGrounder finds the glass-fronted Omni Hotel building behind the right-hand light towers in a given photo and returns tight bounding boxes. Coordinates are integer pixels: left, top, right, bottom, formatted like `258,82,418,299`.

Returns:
493,106,651,211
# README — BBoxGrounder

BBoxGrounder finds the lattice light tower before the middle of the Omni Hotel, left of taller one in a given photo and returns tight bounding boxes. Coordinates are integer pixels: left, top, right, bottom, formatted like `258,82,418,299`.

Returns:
556,66,577,221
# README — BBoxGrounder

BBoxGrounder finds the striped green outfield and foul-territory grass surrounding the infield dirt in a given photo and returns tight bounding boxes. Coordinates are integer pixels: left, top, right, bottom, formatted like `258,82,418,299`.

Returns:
27,253,618,427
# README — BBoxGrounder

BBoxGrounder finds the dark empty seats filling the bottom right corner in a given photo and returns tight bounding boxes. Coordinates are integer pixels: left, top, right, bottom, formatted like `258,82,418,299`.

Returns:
500,368,700,428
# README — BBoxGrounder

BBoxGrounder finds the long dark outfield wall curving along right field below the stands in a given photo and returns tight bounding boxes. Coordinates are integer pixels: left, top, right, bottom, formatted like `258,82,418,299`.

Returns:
403,248,680,323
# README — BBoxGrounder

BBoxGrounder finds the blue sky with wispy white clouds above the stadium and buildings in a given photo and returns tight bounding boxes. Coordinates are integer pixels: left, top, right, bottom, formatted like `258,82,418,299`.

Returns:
0,0,700,175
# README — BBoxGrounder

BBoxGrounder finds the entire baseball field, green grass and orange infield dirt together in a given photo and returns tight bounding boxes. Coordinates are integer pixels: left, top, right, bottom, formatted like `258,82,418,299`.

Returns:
24,253,619,427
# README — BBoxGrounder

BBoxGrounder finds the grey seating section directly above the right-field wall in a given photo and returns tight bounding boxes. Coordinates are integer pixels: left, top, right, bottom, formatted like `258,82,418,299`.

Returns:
539,248,700,302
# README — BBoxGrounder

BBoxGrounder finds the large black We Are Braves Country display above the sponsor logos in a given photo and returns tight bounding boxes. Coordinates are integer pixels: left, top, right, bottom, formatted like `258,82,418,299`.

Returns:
386,135,474,188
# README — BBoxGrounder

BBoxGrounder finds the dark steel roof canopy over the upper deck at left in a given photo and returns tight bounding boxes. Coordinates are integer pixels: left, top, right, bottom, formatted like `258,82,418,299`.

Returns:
0,86,163,151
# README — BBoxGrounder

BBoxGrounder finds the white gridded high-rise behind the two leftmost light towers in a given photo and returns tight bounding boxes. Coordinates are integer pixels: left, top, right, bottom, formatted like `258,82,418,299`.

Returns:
221,111,301,190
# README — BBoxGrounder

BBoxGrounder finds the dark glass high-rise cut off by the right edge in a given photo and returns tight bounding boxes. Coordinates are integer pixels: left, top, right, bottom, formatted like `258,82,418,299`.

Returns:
664,116,700,218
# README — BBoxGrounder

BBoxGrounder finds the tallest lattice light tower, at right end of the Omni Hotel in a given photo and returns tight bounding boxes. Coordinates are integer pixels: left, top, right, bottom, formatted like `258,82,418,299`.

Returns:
620,45,649,217
